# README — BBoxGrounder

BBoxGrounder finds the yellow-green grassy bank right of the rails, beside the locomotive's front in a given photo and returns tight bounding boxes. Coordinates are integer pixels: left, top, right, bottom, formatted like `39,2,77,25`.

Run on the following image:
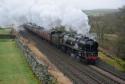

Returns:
99,52,125,72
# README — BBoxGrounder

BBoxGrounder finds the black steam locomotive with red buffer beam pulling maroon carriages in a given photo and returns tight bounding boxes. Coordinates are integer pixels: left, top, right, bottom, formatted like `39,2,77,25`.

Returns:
23,23,98,64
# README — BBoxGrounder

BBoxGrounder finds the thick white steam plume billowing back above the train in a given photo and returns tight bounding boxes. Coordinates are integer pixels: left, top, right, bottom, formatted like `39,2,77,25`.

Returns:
0,0,90,35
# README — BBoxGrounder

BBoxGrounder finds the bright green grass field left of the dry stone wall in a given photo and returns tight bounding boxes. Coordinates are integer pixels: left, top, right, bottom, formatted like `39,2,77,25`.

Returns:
0,29,39,84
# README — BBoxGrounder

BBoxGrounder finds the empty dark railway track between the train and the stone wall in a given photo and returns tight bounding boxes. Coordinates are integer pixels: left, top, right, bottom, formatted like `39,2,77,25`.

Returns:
20,31,124,84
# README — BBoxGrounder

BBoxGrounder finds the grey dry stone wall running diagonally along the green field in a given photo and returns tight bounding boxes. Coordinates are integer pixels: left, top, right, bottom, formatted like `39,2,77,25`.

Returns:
16,37,57,84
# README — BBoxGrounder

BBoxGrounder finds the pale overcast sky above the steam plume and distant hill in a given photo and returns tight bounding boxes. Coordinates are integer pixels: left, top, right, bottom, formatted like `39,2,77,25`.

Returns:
37,0,125,9
